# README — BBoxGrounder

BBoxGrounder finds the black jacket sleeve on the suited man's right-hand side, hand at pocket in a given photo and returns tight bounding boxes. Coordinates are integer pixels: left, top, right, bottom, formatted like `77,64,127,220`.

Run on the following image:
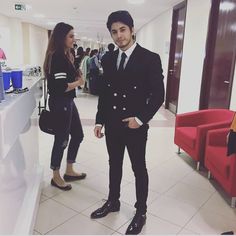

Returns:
137,54,165,124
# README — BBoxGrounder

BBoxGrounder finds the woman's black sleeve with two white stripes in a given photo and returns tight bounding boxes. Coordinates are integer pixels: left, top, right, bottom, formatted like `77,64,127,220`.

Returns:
50,53,68,94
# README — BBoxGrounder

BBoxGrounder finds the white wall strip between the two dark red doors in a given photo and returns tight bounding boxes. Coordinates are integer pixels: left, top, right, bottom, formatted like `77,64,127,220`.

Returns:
177,0,211,113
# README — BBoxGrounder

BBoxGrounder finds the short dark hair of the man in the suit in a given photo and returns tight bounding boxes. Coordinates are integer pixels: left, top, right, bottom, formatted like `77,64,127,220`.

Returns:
107,10,134,31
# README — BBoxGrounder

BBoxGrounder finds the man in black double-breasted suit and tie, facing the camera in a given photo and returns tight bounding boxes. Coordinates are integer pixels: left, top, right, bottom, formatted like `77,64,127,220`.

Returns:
91,11,164,234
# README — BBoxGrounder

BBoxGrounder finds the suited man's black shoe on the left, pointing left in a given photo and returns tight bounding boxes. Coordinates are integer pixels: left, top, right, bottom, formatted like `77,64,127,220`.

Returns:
90,200,120,219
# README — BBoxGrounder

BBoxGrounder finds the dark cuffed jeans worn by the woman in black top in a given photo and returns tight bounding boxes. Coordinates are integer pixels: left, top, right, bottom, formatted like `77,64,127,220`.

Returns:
49,97,84,170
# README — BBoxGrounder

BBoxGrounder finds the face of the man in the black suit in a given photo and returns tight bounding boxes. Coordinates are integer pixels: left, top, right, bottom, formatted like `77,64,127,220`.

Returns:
111,22,134,51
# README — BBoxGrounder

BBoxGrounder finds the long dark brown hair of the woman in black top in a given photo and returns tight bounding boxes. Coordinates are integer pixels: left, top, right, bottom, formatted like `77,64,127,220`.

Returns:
43,22,73,76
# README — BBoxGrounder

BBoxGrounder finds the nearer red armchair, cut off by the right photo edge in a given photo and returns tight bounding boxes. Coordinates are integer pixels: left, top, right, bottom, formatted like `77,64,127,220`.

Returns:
205,128,236,207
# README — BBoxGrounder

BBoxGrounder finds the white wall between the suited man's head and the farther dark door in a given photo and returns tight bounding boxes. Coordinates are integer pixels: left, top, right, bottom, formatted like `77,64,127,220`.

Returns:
136,9,172,88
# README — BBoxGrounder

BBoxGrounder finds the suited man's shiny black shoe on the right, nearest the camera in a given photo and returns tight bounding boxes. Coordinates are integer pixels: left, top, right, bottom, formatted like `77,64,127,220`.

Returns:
125,213,147,234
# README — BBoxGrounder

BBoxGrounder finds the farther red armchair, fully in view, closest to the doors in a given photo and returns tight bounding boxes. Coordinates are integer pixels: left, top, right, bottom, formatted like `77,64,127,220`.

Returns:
174,109,234,170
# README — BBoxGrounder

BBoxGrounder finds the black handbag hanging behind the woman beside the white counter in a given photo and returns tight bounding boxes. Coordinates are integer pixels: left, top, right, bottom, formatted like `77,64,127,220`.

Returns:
39,89,56,135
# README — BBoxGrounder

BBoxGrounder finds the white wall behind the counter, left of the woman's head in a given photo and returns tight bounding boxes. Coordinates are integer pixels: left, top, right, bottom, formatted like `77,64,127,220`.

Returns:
0,14,48,67
